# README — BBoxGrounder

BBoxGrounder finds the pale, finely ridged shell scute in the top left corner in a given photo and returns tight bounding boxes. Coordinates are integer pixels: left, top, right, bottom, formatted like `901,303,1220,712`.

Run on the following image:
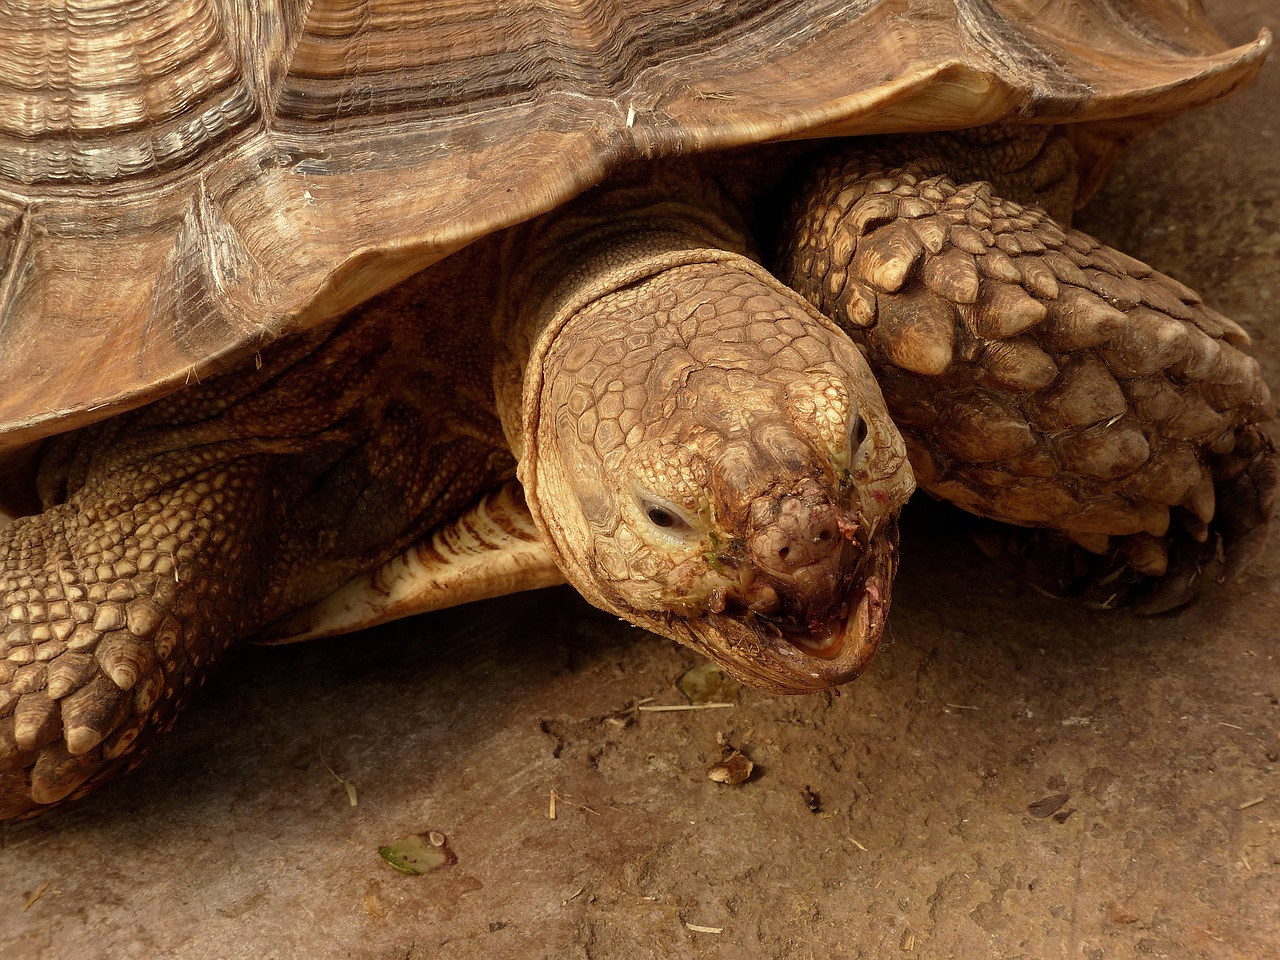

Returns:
0,0,261,187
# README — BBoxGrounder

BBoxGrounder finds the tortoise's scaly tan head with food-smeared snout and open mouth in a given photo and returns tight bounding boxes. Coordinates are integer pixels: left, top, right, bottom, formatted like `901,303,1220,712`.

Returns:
521,261,914,692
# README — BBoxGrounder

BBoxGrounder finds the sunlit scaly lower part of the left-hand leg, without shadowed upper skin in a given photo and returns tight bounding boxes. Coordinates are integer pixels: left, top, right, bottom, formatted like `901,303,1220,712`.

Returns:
0,454,269,819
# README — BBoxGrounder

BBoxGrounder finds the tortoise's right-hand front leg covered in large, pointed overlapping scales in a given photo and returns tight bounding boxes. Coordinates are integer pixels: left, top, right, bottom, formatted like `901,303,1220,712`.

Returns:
780,138,1276,608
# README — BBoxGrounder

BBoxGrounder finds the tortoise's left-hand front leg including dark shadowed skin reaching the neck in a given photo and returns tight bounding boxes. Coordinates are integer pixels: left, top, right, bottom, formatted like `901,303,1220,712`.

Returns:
0,277,513,819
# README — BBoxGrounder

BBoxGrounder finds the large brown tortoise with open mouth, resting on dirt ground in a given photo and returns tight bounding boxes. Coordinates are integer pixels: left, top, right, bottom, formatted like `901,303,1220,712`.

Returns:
0,0,1275,817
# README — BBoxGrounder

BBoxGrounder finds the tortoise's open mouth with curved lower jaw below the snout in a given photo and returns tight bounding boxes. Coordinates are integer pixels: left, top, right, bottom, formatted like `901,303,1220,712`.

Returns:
695,518,897,694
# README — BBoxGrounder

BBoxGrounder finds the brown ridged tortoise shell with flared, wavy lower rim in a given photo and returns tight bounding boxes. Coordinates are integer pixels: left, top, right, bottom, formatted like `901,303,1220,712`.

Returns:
0,0,1270,451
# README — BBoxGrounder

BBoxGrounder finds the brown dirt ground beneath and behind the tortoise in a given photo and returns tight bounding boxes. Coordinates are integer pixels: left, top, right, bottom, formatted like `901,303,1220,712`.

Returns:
0,0,1280,960
